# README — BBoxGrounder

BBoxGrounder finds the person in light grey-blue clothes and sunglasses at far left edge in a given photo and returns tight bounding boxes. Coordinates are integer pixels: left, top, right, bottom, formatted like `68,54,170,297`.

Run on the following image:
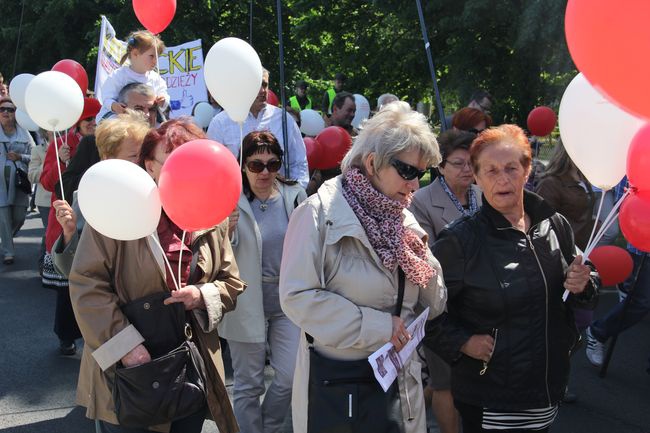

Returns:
0,97,34,265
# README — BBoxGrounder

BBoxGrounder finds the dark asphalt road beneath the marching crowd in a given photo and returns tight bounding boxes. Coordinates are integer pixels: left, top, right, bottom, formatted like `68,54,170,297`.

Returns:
0,213,650,433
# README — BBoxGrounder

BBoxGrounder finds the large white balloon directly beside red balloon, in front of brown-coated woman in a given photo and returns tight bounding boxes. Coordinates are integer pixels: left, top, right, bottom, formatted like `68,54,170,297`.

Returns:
77,159,162,241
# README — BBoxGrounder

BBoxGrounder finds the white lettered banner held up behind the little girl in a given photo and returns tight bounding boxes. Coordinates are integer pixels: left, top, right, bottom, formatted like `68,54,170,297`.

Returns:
95,16,208,118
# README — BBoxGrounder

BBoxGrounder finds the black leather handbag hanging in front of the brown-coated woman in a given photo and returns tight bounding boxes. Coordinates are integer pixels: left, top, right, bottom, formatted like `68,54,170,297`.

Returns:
113,292,206,428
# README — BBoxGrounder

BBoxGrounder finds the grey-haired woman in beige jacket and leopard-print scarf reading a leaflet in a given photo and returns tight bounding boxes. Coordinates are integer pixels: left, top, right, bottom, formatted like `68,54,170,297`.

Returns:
280,105,446,433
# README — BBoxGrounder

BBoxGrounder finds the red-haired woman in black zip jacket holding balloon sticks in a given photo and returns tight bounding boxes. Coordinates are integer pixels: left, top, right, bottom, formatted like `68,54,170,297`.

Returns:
425,125,594,433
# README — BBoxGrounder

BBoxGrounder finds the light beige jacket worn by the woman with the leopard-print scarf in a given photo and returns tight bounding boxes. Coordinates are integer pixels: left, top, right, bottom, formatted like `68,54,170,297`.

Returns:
280,176,447,433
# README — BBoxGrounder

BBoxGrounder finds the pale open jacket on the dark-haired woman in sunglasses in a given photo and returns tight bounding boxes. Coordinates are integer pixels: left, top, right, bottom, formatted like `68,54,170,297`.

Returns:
219,182,307,343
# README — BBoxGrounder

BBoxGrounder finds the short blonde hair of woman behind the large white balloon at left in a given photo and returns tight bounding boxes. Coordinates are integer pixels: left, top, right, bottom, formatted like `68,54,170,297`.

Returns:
95,110,151,159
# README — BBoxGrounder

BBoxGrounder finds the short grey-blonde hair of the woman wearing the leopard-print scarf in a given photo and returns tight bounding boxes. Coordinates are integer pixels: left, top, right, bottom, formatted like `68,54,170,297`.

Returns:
341,106,442,173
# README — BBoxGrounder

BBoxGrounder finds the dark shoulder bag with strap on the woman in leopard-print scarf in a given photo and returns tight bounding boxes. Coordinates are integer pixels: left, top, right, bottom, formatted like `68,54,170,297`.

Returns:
306,268,404,433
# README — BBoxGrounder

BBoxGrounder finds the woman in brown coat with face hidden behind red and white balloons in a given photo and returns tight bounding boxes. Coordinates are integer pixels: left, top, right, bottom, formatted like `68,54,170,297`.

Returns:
70,116,245,433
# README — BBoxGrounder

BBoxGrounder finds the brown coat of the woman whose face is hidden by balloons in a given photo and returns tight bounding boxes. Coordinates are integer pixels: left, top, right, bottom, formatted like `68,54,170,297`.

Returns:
70,221,245,433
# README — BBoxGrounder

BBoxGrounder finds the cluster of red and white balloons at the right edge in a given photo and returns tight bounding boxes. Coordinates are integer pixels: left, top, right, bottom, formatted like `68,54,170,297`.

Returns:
559,0,650,255
